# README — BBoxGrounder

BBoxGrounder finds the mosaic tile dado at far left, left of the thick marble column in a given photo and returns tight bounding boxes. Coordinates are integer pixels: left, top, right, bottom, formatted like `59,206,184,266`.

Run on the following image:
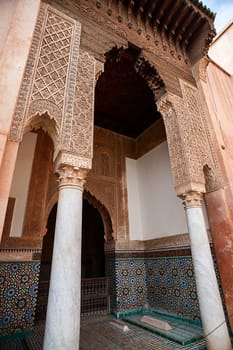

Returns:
0,261,40,336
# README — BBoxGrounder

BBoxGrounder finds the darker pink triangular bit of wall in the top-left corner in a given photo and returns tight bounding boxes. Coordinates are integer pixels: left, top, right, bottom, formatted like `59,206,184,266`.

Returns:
0,0,18,55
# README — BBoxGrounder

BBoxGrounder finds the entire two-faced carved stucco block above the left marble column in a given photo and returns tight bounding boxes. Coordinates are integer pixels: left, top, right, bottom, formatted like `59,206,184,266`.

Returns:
9,3,96,168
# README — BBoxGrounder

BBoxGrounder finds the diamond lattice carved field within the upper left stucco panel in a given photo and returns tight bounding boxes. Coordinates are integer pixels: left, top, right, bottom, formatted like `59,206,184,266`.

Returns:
31,11,72,109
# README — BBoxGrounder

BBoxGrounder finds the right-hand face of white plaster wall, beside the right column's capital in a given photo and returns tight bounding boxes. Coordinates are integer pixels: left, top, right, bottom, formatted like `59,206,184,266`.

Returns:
138,142,188,239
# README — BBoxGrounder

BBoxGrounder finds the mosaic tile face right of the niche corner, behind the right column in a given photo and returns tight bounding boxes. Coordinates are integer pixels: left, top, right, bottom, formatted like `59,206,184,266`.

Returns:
145,256,200,320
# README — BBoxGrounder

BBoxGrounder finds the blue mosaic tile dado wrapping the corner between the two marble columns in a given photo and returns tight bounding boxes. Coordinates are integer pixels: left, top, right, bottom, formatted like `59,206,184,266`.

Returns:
106,256,200,320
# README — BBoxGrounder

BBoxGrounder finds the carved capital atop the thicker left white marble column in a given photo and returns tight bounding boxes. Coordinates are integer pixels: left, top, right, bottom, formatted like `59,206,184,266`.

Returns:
56,165,88,191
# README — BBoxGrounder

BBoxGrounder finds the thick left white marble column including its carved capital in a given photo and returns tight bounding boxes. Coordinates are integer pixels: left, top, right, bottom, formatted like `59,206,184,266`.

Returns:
43,165,87,350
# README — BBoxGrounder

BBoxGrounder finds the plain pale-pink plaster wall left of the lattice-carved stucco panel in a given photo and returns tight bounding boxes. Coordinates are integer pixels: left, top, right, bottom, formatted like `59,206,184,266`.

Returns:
0,0,40,165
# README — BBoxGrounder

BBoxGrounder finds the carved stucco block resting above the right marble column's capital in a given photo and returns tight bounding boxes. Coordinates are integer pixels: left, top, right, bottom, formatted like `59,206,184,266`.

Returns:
157,81,218,195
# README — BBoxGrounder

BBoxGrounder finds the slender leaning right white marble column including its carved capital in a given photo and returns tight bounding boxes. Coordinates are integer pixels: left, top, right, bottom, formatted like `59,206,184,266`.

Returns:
183,192,232,350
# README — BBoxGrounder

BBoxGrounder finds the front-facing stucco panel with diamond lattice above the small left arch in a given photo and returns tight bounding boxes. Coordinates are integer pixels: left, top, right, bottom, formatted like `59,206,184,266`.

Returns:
9,3,81,152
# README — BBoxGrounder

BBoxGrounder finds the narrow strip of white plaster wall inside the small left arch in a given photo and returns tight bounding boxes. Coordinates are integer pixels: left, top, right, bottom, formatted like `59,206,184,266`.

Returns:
10,133,37,237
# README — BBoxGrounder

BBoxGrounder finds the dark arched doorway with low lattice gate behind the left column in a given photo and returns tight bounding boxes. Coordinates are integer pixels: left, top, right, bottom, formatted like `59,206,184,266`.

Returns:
36,199,108,322
